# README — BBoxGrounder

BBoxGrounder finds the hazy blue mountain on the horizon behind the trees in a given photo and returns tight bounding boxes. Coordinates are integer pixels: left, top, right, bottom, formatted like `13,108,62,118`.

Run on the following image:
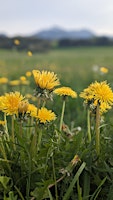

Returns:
32,27,95,40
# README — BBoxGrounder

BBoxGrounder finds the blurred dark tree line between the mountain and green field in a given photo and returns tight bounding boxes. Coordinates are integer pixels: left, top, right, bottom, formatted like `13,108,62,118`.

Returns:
0,36,113,52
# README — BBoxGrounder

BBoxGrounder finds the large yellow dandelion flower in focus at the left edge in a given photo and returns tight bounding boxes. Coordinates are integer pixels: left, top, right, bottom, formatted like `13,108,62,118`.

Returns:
1,92,24,115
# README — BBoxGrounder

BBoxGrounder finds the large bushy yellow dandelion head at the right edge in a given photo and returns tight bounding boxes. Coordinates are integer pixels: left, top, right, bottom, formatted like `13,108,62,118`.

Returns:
80,81,113,112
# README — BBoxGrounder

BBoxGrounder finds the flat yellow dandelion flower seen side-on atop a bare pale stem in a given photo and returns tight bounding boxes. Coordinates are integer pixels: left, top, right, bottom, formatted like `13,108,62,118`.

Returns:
54,87,77,98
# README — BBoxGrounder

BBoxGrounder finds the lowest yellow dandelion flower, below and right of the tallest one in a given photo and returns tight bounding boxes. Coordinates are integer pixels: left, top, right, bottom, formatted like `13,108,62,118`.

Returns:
38,107,56,124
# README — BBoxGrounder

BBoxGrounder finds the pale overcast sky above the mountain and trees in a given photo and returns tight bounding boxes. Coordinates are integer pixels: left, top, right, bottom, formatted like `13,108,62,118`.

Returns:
0,0,113,36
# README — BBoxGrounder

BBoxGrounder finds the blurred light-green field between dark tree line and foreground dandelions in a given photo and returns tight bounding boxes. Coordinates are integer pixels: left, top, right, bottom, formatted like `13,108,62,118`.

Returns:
0,47,113,88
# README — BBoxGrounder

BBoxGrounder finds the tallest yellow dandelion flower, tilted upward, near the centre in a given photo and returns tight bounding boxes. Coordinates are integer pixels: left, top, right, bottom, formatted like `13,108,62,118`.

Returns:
33,70,60,90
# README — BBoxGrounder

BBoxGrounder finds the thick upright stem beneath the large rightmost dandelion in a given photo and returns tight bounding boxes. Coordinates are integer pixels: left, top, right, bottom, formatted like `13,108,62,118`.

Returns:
95,103,100,156
